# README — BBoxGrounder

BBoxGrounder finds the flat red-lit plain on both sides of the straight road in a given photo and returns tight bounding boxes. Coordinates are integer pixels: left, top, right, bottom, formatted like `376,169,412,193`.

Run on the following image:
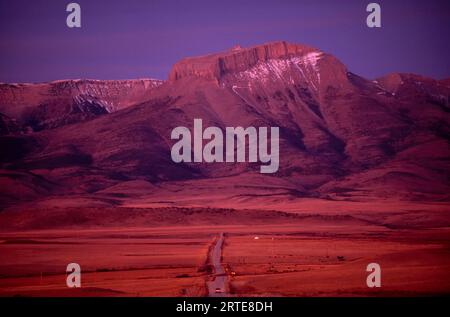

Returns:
0,201,450,296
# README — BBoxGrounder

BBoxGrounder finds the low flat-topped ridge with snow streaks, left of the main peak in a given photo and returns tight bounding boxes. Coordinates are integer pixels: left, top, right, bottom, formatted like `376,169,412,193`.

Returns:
0,79,162,133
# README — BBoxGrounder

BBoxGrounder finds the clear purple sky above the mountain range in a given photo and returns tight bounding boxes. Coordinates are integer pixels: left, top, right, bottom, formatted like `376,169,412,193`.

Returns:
0,0,450,82
